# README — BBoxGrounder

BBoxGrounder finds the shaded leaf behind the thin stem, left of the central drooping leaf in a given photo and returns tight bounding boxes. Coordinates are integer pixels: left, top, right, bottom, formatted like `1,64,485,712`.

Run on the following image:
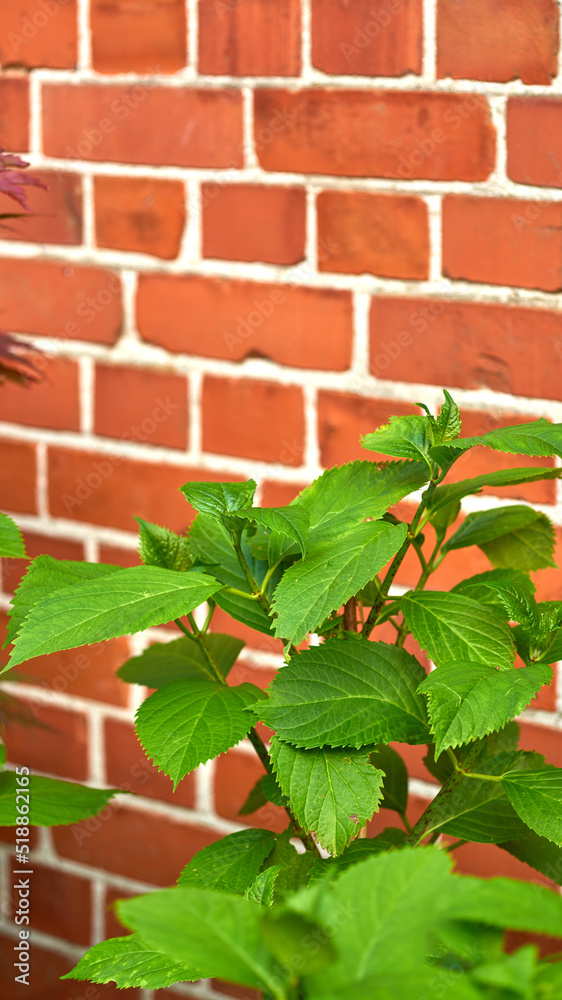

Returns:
189,514,277,635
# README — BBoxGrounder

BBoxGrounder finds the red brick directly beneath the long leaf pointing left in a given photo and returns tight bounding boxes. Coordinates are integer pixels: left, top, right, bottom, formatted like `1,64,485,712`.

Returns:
14,638,130,705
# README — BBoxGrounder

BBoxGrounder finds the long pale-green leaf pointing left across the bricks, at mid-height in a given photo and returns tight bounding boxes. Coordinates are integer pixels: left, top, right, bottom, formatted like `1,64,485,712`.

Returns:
10,566,221,667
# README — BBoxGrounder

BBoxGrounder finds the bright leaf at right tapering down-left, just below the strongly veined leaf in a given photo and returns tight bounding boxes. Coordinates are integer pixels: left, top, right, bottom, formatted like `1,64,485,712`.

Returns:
418,663,552,756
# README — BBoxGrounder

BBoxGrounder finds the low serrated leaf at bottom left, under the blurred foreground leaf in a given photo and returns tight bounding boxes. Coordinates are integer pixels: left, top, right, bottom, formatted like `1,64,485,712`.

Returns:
61,934,197,990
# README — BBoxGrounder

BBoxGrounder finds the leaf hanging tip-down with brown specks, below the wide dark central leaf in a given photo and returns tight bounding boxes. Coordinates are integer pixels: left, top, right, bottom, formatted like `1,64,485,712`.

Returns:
271,739,384,855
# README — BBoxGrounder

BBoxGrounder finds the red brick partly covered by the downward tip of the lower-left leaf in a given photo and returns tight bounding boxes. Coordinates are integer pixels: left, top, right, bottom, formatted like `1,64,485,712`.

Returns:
105,716,195,809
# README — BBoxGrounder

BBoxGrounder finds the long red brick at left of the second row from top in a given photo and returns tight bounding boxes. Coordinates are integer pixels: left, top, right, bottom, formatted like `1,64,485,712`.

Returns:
43,84,243,167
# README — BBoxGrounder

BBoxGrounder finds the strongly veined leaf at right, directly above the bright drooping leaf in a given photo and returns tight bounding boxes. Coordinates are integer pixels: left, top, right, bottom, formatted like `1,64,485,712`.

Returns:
401,590,515,670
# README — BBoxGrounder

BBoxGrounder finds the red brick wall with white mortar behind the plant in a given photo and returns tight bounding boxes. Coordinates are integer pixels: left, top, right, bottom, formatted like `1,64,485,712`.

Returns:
0,0,562,1000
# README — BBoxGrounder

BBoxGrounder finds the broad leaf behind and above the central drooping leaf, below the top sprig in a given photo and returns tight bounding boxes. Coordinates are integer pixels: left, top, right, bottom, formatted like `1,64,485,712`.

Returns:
293,461,429,544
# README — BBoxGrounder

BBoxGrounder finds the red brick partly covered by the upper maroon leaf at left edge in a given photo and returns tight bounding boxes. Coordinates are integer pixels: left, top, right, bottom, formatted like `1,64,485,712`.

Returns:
2,167,82,245
